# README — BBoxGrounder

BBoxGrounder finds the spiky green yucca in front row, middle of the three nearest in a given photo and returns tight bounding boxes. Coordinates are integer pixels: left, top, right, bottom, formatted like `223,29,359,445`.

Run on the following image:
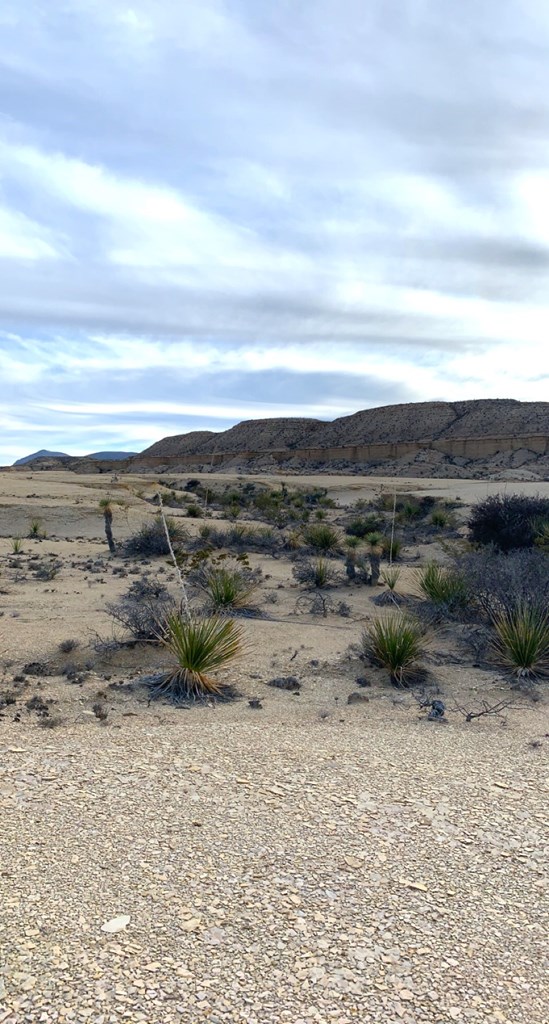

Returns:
362,614,426,686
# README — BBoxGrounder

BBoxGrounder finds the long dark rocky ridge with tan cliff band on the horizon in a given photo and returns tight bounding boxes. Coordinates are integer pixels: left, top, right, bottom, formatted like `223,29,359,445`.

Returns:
17,399,549,480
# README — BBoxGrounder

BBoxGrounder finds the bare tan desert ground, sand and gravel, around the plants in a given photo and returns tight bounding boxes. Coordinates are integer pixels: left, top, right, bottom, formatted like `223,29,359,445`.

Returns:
0,472,549,1024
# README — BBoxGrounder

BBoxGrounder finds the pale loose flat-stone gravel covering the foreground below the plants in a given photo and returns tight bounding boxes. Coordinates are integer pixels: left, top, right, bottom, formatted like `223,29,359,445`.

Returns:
0,708,548,1024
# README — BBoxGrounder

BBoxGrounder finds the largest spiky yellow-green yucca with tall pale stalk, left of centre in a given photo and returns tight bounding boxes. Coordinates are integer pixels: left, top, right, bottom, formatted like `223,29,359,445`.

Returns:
151,614,245,703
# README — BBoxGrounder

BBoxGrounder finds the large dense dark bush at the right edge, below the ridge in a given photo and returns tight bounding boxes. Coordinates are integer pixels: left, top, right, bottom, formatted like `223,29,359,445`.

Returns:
467,495,549,551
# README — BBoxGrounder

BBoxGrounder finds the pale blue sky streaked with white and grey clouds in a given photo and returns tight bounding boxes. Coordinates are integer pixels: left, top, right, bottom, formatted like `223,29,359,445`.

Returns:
0,0,549,464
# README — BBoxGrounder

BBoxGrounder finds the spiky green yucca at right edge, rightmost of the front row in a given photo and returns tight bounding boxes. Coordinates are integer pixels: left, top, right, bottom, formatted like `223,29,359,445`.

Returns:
493,600,549,678
